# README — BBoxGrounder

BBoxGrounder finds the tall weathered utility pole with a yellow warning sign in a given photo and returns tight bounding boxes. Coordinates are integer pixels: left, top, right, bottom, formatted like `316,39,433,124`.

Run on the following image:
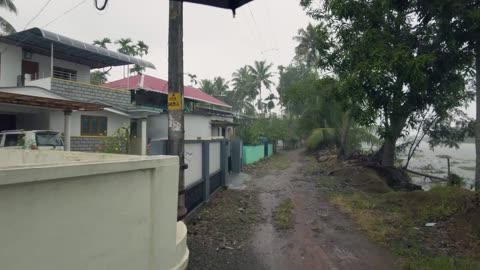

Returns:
167,0,186,220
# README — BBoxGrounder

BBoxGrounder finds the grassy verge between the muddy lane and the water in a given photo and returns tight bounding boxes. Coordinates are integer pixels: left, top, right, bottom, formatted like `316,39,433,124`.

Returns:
305,154,480,270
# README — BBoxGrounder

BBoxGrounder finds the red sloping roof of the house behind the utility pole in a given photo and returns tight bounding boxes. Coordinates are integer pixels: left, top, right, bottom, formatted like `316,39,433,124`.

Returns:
104,75,231,107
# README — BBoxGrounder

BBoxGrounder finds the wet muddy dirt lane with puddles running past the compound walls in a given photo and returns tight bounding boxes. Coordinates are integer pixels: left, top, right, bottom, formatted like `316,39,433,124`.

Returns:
250,150,398,270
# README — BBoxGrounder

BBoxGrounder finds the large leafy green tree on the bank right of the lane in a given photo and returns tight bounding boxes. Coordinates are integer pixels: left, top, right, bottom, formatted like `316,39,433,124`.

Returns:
299,0,472,165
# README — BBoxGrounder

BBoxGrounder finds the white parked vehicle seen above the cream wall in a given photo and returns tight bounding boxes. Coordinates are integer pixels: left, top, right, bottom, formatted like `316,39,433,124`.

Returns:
0,130,63,151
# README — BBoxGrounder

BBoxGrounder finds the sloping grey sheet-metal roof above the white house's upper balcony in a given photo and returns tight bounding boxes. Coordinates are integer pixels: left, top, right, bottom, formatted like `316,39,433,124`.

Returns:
0,28,155,69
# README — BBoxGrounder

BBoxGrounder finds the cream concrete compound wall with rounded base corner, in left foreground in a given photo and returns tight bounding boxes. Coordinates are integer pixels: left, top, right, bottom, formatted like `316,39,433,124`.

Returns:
0,150,188,270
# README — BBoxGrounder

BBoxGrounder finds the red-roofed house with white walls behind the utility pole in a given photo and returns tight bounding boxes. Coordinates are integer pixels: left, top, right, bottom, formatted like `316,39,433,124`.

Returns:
104,75,235,154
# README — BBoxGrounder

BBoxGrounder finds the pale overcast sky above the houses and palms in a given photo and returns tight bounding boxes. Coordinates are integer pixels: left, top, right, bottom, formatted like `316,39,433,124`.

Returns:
6,0,309,96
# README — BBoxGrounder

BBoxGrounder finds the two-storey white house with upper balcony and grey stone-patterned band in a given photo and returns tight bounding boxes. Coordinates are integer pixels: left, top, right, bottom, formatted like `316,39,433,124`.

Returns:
0,28,158,151
